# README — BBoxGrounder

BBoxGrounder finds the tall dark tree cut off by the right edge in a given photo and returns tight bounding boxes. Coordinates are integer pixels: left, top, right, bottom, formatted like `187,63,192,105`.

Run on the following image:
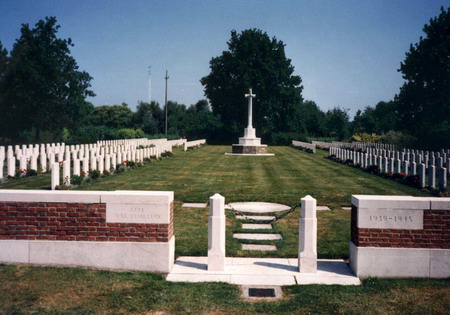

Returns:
395,8,450,149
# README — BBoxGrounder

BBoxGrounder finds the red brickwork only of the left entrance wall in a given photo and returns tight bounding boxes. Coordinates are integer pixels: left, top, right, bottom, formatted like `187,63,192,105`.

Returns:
0,202,173,242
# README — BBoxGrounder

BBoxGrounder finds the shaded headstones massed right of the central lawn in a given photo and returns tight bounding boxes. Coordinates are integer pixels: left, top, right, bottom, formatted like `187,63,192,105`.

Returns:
329,147,450,189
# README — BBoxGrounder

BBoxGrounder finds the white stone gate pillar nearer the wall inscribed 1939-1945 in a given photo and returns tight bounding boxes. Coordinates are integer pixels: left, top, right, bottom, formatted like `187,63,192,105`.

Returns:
298,195,317,273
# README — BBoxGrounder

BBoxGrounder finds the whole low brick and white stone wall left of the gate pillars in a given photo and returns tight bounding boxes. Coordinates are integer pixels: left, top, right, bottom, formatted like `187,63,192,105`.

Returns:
0,190,175,272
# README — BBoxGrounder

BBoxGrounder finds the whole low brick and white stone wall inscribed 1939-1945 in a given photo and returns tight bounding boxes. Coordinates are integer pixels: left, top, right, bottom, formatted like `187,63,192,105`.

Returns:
350,195,450,278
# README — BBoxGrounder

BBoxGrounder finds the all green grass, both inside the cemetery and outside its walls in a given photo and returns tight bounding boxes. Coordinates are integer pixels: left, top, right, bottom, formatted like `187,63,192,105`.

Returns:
0,146,450,314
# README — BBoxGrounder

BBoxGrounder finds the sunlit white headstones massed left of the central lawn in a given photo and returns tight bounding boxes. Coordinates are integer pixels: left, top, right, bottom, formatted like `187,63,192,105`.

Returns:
0,138,187,186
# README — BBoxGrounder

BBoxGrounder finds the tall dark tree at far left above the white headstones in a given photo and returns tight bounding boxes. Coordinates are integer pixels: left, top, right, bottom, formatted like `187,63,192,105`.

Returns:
0,17,95,142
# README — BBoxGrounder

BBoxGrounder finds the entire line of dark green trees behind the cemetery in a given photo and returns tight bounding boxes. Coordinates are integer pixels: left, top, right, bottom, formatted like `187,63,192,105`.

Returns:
0,8,450,149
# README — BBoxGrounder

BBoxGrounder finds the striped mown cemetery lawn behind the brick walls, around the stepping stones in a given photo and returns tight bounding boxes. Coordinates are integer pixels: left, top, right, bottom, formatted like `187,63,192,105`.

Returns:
0,146,426,258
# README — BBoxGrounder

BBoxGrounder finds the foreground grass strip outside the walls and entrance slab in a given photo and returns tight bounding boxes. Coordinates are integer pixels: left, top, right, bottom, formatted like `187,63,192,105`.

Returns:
0,265,450,314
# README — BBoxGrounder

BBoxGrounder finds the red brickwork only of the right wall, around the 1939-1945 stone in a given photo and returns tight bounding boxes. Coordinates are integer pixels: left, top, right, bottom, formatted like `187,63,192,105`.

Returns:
351,205,450,248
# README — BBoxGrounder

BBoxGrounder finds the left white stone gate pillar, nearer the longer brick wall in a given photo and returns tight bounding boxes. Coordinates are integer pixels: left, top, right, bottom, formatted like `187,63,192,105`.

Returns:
208,194,225,271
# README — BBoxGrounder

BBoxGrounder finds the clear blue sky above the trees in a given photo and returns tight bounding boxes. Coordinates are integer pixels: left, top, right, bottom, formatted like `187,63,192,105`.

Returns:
0,0,450,115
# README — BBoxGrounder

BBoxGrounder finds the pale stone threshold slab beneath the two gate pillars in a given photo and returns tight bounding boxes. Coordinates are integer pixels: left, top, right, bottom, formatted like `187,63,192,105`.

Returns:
166,257,361,285
